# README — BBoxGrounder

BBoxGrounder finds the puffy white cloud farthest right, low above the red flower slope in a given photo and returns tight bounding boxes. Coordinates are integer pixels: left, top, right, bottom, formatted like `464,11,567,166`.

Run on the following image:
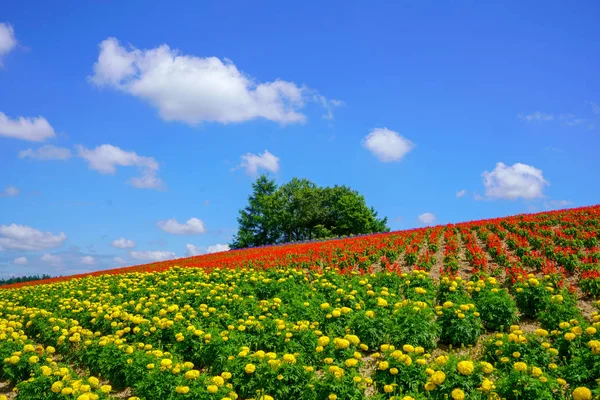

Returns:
482,162,548,200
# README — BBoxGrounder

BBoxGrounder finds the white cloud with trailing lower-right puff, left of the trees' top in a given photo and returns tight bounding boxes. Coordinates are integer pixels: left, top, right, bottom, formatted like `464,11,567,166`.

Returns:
75,144,164,189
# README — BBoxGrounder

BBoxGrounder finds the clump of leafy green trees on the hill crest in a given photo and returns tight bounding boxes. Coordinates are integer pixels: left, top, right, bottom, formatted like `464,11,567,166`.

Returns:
230,175,390,249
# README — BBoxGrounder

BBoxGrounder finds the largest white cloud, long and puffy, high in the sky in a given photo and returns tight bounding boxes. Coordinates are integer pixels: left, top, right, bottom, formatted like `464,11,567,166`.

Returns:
89,38,338,125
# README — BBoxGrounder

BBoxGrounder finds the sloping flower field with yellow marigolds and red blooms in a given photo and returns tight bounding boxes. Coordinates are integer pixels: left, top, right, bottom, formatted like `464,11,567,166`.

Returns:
0,206,600,400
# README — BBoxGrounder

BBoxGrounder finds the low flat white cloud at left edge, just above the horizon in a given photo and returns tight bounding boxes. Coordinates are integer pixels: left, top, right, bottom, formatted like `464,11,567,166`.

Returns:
0,224,67,251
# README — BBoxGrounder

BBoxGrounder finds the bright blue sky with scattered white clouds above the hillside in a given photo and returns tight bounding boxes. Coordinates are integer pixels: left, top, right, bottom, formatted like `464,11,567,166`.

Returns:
0,1,600,277
